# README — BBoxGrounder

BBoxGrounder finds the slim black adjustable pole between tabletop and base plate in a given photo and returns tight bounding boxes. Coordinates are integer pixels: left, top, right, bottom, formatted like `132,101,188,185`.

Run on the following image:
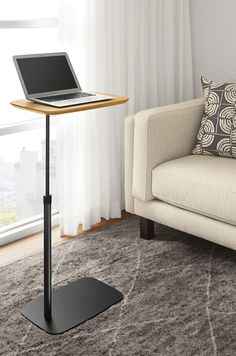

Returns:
43,115,52,320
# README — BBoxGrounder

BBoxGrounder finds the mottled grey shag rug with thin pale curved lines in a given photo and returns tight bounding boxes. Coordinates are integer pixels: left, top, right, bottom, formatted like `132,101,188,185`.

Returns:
0,218,236,356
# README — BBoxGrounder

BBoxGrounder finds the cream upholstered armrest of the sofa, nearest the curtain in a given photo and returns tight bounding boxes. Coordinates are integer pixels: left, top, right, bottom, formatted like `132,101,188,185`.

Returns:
132,99,204,201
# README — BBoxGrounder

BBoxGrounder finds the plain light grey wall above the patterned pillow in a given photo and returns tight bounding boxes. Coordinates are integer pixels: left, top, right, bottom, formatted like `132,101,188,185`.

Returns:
190,0,236,97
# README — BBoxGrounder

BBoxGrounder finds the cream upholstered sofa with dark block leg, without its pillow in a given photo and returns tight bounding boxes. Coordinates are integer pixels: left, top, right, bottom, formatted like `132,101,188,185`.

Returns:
125,99,236,249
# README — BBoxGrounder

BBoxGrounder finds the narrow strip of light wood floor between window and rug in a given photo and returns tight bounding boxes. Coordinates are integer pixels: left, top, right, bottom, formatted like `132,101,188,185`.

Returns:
0,211,133,266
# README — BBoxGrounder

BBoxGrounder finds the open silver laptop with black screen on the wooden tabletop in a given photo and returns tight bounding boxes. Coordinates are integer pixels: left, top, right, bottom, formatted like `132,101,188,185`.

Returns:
13,52,112,107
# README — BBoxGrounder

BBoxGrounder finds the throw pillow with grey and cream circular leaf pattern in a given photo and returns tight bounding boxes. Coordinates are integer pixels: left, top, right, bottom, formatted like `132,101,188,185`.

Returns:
192,77,236,158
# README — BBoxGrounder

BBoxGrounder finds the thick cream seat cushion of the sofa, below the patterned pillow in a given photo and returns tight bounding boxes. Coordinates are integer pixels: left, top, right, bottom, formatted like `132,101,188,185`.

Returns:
152,155,236,224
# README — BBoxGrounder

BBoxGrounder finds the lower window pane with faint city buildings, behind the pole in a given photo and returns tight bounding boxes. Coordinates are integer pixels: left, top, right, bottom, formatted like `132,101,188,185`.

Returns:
0,127,57,227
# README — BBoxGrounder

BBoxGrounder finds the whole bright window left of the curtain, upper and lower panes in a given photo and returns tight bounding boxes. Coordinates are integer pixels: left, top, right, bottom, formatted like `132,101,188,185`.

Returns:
0,0,59,244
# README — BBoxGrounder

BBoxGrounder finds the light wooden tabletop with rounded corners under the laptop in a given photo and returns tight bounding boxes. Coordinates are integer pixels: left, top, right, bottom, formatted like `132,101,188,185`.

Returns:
11,93,129,115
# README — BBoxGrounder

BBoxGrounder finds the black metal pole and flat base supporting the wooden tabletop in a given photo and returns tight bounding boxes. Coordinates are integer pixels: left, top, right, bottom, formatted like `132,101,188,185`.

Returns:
21,115,123,334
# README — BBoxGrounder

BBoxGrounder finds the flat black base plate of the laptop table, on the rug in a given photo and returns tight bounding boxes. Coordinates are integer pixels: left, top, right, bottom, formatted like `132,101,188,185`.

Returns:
22,277,123,334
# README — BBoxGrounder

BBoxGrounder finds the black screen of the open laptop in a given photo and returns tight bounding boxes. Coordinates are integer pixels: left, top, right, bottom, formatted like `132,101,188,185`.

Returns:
16,55,80,95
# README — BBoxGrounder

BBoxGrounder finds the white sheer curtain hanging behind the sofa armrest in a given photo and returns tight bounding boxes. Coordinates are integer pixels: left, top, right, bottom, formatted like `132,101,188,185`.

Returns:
58,0,193,235
